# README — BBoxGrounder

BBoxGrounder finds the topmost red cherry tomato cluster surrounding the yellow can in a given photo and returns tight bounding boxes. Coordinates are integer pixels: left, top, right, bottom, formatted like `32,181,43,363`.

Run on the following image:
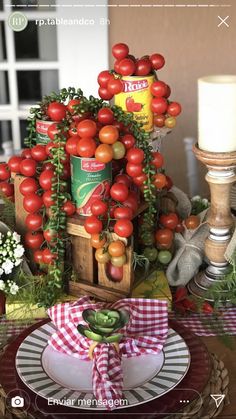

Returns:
98,43,181,128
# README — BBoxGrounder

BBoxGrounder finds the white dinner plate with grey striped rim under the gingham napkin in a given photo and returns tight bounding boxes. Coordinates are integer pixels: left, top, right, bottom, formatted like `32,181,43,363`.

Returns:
16,323,190,410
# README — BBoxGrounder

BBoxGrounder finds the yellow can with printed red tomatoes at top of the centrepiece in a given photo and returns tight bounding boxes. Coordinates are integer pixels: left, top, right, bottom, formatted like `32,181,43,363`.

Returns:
115,75,155,132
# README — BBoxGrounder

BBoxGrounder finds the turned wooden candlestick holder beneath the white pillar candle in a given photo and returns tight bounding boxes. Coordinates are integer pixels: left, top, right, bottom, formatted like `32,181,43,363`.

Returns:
188,144,236,299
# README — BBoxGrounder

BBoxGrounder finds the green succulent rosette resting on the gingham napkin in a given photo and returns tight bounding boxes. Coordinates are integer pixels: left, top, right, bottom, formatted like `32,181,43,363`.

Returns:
77,309,129,343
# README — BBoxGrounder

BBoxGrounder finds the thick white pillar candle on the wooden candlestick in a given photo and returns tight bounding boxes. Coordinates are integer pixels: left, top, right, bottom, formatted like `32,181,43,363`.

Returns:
198,75,236,153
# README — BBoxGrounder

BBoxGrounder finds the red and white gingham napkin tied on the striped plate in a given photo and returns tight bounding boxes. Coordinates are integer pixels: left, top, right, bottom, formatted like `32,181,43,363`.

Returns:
48,296,168,409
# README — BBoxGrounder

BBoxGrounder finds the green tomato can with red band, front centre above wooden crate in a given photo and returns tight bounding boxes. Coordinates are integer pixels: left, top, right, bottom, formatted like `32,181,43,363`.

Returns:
71,156,112,215
